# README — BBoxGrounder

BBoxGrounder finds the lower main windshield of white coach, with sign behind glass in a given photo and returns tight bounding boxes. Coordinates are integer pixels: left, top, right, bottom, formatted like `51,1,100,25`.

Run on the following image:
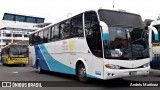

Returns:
104,27,149,60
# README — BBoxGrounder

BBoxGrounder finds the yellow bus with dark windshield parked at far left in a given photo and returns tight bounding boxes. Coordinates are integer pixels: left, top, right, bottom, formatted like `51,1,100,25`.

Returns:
1,44,29,66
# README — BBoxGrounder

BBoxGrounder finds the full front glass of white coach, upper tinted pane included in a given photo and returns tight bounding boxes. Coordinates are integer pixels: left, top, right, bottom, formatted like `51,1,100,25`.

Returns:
99,10,149,60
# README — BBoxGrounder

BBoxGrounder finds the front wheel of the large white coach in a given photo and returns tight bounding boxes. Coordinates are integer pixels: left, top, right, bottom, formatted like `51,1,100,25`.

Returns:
77,63,88,82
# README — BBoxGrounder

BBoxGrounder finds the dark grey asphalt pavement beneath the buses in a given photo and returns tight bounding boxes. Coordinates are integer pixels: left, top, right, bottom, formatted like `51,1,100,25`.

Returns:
0,64,160,90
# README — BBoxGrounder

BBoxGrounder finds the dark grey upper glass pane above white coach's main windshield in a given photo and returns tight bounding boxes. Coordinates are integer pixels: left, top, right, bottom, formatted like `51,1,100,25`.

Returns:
98,9,144,29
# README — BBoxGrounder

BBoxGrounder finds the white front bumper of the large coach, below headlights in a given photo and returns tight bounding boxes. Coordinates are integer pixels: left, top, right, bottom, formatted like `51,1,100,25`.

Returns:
104,67,150,80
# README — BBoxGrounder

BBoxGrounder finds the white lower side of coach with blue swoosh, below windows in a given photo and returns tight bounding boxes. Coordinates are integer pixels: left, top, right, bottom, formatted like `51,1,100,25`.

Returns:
30,38,103,79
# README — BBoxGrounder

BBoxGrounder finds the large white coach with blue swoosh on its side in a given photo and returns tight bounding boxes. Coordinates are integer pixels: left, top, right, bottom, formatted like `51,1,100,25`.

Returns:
29,9,150,81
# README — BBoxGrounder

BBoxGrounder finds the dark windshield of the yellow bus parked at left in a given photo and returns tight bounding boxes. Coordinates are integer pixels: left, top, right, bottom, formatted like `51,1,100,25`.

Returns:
10,45,28,57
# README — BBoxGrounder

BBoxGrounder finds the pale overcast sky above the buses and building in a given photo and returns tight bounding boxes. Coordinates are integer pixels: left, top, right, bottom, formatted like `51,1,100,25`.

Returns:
0,0,160,23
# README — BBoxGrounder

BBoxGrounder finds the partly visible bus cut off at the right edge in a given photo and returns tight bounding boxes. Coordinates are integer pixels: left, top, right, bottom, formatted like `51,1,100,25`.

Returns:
149,20,160,69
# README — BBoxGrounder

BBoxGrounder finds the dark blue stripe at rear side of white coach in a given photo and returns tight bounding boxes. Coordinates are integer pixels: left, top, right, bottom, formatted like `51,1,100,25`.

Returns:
34,45,49,70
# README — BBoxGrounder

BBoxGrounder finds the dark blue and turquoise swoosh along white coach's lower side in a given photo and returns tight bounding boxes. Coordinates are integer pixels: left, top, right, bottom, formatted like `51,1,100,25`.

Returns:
34,45,100,79
